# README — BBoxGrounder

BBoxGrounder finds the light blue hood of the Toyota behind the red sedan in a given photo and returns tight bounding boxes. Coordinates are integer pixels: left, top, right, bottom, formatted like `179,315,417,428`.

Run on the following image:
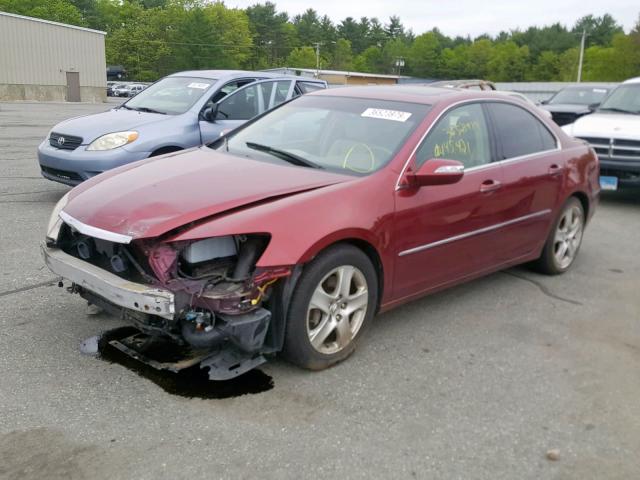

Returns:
53,108,170,145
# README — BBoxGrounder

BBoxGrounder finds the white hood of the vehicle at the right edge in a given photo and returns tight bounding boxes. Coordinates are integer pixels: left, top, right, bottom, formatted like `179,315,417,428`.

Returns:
570,113,640,140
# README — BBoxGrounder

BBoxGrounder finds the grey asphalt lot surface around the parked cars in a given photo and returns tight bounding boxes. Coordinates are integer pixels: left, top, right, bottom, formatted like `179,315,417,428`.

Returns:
0,101,640,480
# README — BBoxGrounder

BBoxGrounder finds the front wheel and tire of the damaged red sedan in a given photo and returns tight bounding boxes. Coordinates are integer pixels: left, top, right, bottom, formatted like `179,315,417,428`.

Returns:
283,244,378,370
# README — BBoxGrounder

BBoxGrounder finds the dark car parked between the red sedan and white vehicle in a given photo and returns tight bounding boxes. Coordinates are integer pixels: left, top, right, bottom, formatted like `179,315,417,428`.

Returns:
541,84,613,126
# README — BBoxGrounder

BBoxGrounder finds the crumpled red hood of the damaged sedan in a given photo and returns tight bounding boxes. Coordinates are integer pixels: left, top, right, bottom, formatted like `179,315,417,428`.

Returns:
64,147,356,239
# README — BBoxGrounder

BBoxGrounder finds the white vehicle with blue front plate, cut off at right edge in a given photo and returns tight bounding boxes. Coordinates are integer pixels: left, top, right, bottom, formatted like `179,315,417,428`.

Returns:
562,77,640,190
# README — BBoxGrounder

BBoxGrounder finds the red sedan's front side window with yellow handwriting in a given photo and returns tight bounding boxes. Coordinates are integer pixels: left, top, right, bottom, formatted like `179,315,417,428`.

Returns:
416,103,491,168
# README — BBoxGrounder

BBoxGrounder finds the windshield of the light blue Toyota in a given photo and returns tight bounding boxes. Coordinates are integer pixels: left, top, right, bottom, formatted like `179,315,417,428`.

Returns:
125,77,215,115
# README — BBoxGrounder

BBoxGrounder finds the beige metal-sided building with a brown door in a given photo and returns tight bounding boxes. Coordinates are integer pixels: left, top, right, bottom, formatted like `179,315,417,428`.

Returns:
0,12,107,102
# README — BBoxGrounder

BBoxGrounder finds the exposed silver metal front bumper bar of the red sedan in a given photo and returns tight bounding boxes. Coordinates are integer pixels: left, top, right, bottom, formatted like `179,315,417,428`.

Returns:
42,244,175,320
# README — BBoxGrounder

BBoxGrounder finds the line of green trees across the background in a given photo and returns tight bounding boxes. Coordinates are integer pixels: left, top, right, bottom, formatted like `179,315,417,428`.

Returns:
0,0,640,82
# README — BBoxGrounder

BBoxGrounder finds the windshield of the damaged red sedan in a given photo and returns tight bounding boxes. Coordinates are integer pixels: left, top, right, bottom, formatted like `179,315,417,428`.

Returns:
211,95,431,175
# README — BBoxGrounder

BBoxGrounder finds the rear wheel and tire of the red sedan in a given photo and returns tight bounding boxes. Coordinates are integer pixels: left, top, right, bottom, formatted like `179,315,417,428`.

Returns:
533,197,585,275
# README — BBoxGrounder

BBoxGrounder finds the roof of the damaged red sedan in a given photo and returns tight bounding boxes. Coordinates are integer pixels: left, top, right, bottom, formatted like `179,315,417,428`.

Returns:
307,85,495,105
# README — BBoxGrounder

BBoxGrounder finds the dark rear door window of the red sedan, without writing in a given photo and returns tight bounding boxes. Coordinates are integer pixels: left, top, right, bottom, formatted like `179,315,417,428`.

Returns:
486,103,557,160
